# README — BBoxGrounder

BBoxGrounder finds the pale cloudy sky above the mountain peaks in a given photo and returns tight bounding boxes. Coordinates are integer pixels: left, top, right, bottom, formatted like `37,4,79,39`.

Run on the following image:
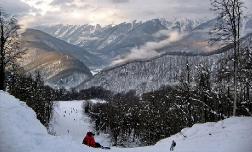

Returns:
0,0,252,26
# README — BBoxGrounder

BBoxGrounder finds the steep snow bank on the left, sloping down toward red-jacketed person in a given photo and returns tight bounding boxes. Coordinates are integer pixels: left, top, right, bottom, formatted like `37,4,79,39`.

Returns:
0,91,101,152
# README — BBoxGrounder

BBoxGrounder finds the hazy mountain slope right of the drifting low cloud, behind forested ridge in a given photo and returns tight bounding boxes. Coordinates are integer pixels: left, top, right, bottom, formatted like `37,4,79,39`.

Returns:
157,17,252,54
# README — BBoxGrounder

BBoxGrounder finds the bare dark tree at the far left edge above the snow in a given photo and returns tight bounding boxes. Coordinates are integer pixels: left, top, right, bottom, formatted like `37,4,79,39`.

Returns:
0,8,24,90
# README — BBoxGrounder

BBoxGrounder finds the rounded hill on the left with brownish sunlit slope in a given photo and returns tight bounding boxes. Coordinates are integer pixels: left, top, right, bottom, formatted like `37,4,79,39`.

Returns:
20,29,95,88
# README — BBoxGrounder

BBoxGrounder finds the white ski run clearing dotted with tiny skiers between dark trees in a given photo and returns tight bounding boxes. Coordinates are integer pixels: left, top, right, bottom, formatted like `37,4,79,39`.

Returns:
50,100,110,146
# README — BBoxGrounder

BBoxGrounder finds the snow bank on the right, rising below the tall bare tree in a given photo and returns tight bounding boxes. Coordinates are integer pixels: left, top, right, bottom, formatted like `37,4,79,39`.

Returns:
155,117,252,152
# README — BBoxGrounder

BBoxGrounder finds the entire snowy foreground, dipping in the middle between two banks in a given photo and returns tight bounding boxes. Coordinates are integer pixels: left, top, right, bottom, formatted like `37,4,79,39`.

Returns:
0,91,252,152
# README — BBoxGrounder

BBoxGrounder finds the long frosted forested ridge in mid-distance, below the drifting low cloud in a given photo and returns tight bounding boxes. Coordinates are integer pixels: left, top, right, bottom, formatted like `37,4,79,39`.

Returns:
77,34,252,94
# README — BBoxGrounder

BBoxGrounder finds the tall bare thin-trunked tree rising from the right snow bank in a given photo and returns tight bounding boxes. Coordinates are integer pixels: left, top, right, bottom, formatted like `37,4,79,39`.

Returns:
210,0,243,116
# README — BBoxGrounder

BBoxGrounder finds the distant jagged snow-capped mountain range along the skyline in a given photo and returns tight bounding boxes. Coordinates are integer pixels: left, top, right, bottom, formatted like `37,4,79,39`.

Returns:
36,16,252,65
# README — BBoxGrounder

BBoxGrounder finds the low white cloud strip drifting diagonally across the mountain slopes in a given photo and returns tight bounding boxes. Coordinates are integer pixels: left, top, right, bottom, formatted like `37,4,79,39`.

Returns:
112,30,185,65
